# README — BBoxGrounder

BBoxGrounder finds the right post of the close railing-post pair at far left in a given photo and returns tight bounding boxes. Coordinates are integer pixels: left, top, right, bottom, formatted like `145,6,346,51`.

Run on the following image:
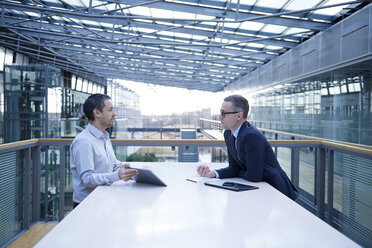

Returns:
32,145,40,222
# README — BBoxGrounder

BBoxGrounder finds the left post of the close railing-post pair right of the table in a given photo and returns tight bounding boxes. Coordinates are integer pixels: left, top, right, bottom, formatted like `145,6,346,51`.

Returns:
315,148,325,220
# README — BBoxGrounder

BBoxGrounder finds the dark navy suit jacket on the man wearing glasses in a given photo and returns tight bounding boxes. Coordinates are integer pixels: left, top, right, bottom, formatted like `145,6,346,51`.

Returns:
217,121,297,200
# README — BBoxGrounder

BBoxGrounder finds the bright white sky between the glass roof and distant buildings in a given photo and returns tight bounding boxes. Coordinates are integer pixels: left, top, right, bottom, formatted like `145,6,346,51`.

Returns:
120,81,226,115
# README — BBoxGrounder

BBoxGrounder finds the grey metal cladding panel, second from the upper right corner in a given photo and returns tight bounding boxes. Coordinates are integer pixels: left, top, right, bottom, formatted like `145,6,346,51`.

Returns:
320,24,341,68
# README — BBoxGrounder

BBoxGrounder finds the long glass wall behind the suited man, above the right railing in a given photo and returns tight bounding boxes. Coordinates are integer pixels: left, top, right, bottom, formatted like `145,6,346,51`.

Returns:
249,61,372,145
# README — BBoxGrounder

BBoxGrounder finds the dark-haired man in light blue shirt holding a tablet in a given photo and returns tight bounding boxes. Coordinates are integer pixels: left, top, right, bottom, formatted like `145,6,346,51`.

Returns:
70,94,138,208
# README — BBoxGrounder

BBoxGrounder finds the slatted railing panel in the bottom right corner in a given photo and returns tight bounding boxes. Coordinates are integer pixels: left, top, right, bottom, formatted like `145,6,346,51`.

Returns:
333,152,372,247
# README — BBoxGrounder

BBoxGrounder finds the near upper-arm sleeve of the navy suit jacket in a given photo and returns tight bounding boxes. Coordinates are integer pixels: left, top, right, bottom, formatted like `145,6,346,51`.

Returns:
240,133,265,182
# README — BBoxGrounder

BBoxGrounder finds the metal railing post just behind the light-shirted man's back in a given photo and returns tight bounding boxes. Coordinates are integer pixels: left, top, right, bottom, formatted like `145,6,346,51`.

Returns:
58,145,65,221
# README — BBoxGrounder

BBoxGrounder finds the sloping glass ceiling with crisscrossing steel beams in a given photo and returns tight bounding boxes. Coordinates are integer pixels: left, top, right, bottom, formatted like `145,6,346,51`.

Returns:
0,0,367,92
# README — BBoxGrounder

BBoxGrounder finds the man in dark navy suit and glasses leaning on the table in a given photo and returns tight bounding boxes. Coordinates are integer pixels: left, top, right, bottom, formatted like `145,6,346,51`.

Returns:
197,95,297,200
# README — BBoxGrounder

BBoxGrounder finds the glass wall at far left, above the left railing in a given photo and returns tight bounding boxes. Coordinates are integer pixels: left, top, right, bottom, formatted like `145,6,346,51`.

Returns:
4,64,61,142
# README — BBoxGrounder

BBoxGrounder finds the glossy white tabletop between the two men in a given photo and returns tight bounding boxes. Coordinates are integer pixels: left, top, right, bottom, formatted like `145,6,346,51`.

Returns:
35,163,359,248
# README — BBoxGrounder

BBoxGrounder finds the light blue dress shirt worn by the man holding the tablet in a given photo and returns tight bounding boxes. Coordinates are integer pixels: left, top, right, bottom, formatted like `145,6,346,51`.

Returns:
70,124,122,203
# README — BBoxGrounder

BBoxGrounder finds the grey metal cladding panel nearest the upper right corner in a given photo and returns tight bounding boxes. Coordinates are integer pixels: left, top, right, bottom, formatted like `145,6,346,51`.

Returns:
341,8,369,61
